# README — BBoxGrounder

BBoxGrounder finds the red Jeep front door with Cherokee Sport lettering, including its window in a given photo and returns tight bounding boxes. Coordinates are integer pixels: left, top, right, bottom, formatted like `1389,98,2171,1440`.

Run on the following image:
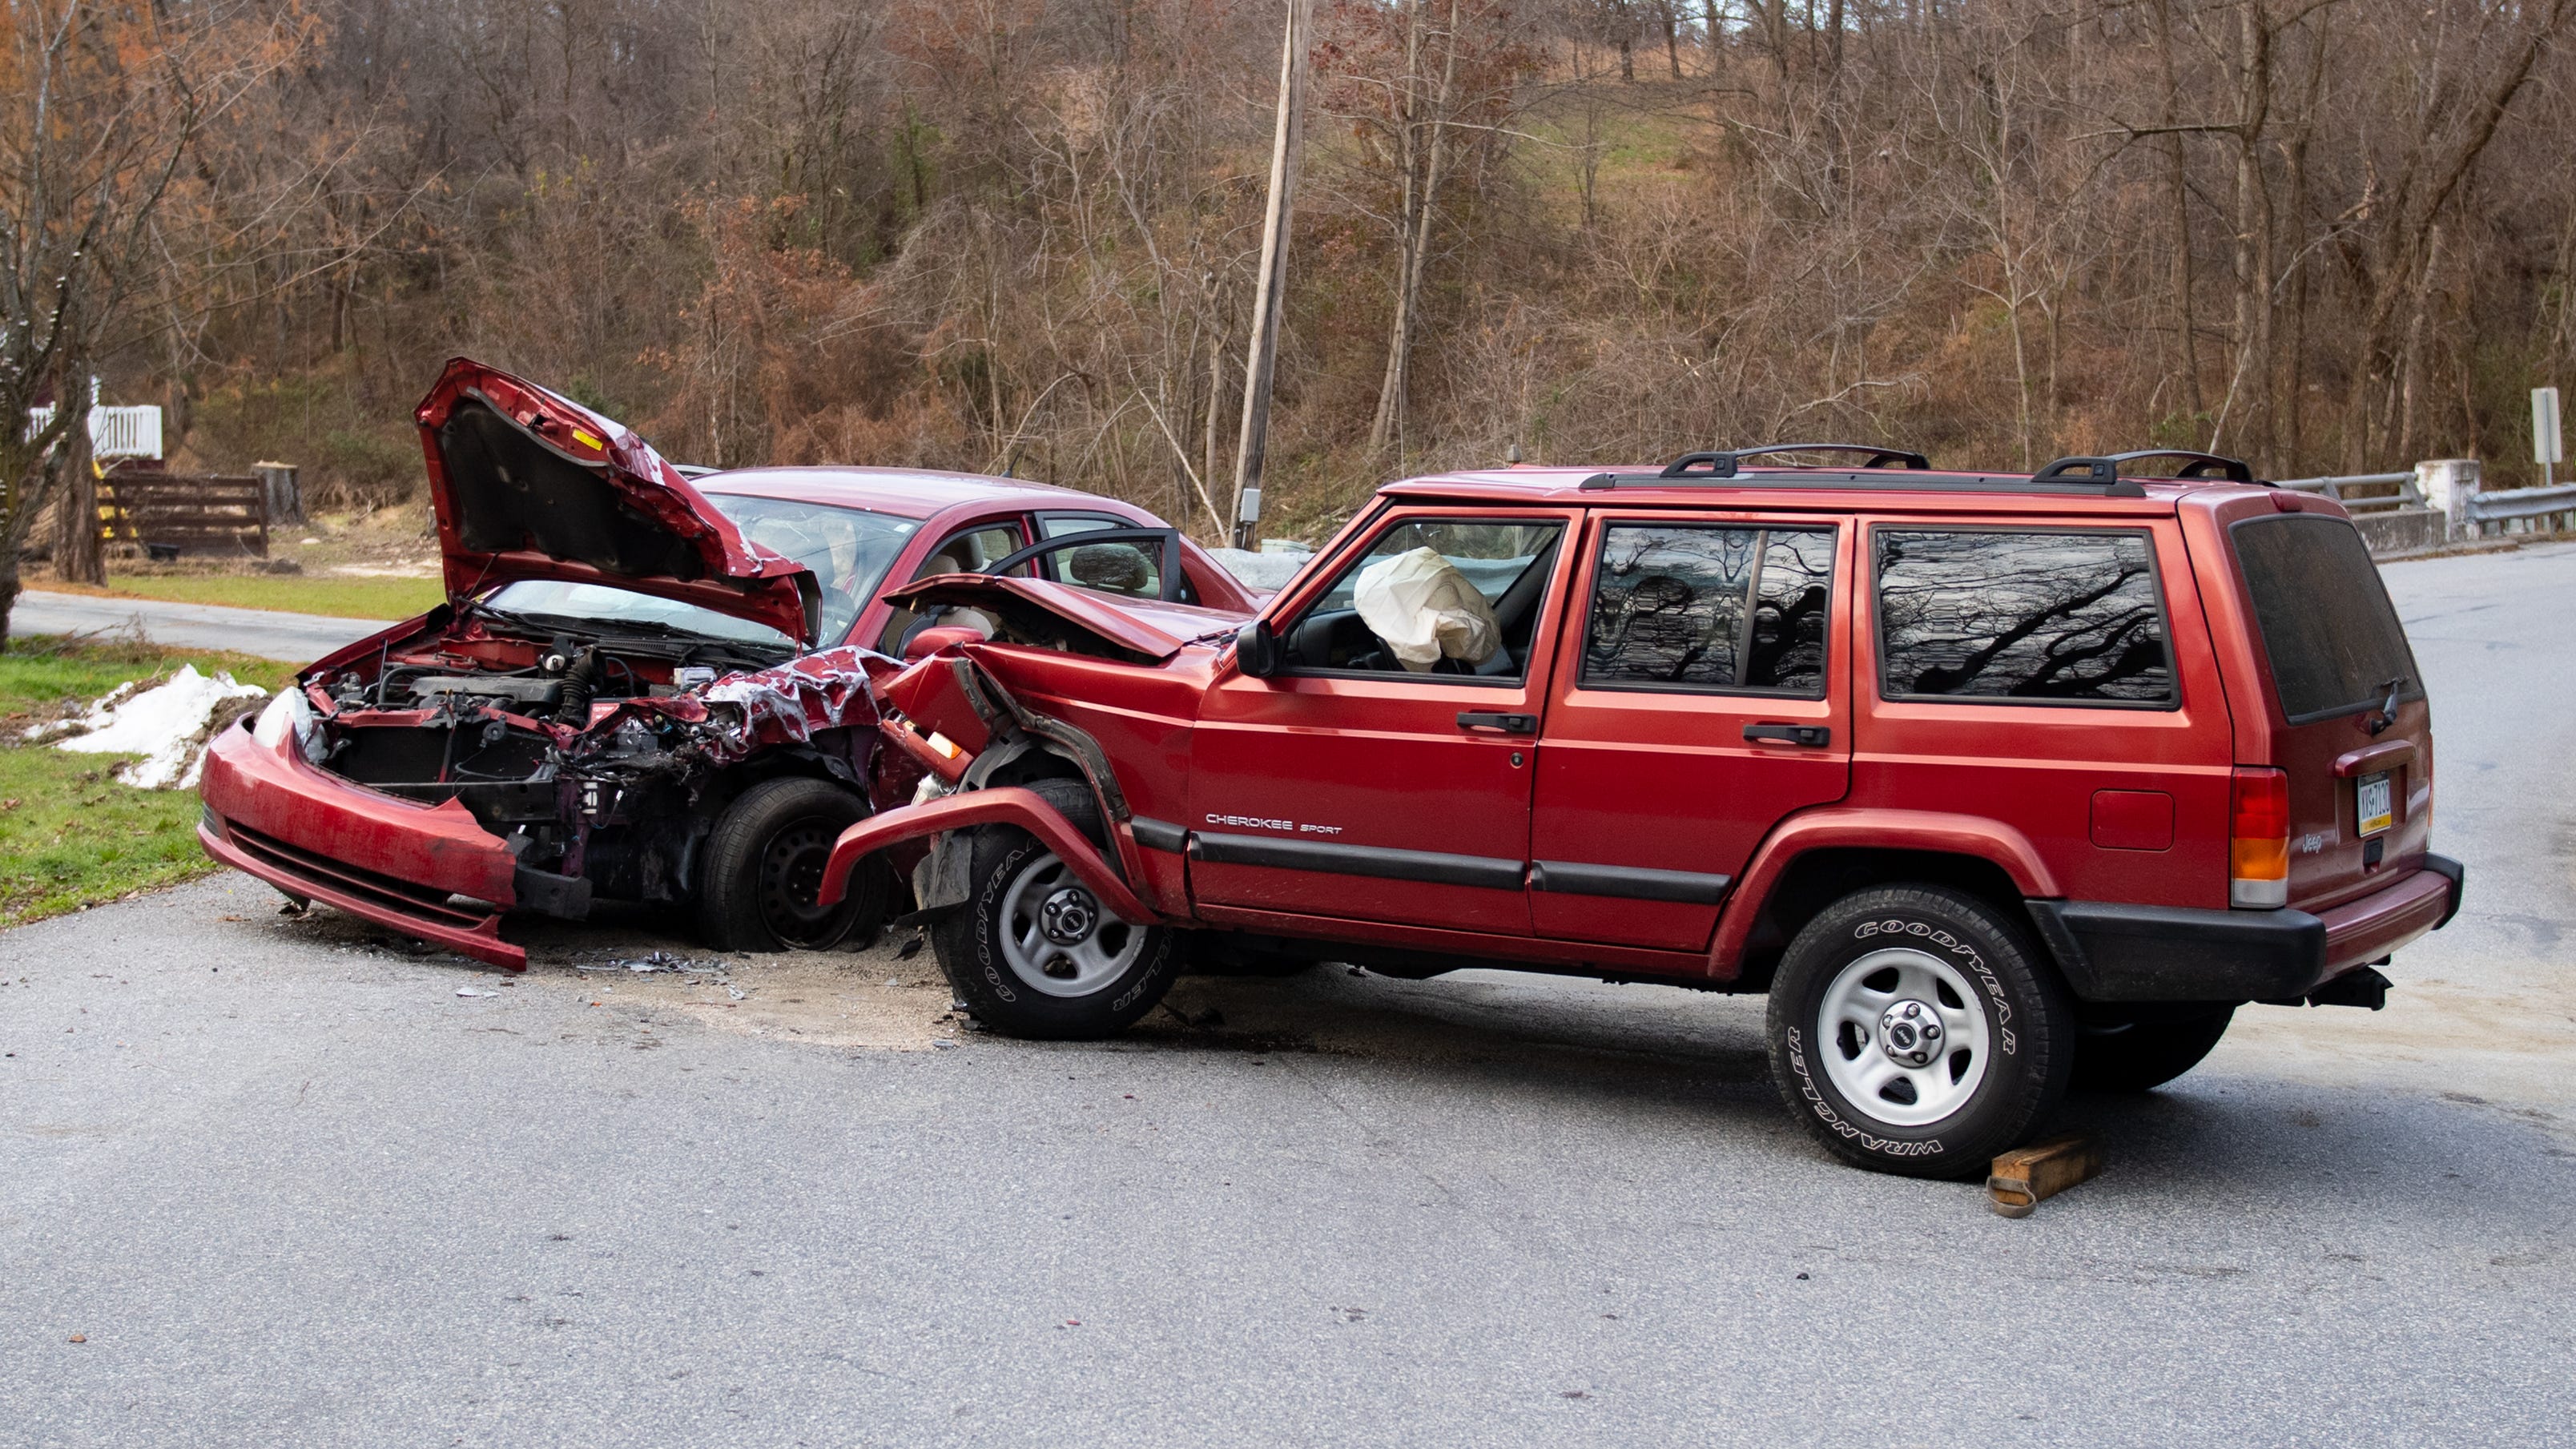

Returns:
1188,508,1574,936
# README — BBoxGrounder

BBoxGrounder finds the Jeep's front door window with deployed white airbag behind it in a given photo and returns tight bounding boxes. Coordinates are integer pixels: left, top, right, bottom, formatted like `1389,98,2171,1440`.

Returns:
1280,518,1564,683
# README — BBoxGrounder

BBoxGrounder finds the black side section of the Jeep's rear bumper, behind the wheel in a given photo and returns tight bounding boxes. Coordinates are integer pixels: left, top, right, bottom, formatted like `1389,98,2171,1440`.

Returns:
2025,900,2326,1000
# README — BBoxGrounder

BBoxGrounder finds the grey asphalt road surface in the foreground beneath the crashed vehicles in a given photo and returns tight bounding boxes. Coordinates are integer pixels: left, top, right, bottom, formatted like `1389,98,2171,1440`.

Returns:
0,546,2576,1447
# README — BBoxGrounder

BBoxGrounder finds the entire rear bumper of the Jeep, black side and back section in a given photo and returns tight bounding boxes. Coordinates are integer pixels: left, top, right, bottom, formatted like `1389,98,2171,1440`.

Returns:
2027,856,2462,1000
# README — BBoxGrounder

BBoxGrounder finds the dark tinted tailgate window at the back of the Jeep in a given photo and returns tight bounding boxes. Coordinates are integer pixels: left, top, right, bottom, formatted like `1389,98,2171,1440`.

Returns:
2231,513,2424,722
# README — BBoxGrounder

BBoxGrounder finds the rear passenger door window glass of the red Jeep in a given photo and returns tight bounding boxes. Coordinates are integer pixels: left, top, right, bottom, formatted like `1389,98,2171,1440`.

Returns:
1582,523,1834,698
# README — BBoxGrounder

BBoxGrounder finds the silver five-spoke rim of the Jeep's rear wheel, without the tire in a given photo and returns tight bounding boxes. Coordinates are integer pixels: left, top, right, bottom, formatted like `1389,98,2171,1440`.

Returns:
1816,946,1991,1127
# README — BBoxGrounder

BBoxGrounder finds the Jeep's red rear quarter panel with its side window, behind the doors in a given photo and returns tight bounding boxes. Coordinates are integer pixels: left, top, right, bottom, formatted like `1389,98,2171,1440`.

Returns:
1852,510,2233,908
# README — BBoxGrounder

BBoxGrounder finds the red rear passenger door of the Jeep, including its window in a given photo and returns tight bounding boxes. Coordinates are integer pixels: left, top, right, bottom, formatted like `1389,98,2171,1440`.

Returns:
1530,510,1852,949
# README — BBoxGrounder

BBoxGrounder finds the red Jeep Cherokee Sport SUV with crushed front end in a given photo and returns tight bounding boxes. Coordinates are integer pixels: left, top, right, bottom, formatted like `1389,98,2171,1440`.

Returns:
824,446,2460,1176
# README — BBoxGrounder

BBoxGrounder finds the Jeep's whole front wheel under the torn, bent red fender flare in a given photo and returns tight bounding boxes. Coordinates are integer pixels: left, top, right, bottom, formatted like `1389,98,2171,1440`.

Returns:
930,779,1180,1041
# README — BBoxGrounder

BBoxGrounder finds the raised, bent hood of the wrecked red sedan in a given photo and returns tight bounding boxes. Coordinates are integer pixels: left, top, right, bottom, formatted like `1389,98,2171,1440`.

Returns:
415,358,822,647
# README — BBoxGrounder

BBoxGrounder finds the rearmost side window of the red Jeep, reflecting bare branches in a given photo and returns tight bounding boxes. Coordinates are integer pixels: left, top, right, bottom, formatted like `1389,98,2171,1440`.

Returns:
1873,529,2177,709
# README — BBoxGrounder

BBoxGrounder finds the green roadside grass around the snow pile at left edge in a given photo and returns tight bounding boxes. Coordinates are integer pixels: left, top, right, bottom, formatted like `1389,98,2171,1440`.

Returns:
0,637,294,926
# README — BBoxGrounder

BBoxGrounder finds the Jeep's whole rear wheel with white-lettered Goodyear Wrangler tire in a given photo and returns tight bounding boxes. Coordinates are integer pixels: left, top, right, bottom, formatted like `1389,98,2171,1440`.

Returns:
1769,887,2074,1178
